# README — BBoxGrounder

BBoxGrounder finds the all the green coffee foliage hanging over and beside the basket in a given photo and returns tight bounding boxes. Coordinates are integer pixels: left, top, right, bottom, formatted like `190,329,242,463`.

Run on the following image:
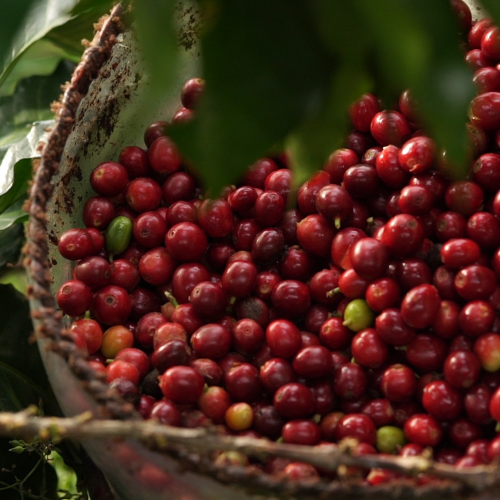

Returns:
0,0,500,499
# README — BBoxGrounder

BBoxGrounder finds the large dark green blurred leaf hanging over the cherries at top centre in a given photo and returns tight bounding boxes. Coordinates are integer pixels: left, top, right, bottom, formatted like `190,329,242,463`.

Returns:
169,0,335,195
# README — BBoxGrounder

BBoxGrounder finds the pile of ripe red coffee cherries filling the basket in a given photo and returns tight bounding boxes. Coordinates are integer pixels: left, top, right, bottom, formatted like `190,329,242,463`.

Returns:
57,2,500,484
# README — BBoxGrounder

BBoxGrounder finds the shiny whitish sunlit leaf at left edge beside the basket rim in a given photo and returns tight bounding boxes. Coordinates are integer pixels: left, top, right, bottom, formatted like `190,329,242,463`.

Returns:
0,120,54,213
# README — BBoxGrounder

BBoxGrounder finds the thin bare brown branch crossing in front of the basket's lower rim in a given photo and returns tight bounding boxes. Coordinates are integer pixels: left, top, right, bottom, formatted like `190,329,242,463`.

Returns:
0,407,500,490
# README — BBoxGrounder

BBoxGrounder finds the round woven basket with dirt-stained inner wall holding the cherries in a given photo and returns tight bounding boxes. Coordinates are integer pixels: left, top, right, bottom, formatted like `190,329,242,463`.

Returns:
26,2,500,500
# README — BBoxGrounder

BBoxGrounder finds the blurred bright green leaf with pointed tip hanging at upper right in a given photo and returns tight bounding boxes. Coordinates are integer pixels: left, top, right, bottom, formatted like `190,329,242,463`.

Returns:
355,0,474,176
